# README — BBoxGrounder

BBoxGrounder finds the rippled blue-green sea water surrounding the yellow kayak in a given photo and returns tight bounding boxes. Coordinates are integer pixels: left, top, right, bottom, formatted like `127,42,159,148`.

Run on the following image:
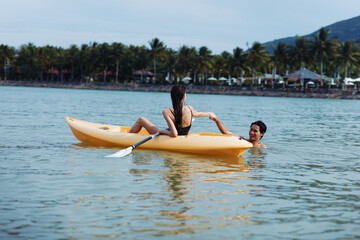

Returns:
0,87,360,239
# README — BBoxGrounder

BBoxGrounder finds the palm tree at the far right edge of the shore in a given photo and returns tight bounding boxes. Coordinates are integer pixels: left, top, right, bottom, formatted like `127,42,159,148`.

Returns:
338,41,360,78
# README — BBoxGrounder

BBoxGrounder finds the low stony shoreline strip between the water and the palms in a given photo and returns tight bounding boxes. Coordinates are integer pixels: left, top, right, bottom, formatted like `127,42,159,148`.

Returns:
0,80,360,100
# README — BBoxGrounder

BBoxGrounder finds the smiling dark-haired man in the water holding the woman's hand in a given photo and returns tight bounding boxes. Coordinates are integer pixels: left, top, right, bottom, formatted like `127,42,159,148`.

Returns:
209,114,266,148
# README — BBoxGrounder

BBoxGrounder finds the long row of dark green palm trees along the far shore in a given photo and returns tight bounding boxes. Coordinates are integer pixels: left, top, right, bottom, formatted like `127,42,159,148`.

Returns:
0,28,360,84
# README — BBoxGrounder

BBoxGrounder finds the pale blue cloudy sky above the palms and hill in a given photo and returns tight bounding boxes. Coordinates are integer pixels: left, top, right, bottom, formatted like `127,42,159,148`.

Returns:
0,0,360,54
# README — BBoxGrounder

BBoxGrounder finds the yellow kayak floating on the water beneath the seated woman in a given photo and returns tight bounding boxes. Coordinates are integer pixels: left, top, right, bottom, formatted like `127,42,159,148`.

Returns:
66,117,253,157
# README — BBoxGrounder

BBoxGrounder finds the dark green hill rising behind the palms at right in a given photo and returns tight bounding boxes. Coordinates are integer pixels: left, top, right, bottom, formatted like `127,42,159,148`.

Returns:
263,16,360,54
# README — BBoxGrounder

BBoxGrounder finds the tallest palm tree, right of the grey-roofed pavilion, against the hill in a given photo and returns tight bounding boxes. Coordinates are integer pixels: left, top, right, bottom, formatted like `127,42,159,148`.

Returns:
310,28,338,78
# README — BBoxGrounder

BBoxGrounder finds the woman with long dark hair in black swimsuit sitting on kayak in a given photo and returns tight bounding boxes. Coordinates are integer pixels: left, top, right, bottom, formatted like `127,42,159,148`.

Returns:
129,85,216,137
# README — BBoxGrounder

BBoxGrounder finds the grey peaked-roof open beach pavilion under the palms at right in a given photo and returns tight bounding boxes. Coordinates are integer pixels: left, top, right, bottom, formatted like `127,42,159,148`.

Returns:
284,68,322,88
